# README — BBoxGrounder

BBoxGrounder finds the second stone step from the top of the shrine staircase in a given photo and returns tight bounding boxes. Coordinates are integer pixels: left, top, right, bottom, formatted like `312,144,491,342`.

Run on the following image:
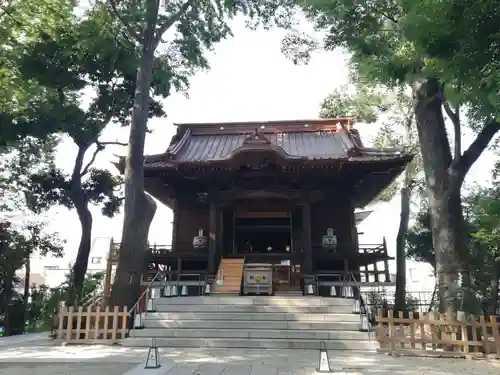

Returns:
156,298,352,314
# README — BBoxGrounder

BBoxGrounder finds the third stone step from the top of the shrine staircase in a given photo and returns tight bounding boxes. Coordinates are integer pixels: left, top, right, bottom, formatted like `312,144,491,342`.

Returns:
147,311,360,323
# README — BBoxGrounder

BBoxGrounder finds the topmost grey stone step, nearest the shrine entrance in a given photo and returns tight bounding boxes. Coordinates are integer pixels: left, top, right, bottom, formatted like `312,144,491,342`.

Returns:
156,296,353,306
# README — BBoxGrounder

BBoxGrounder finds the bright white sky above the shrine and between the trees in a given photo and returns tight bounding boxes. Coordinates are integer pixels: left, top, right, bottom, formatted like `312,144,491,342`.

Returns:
34,16,492,290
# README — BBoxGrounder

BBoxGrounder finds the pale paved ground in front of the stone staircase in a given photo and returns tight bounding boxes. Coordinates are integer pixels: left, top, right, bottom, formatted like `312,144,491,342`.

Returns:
0,339,500,375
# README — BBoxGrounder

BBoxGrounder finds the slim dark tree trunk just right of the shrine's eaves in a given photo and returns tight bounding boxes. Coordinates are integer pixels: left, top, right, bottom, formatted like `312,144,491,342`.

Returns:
394,186,411,311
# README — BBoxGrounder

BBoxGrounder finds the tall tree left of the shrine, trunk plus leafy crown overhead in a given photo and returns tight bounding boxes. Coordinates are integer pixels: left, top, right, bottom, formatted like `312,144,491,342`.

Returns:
106,0,295,307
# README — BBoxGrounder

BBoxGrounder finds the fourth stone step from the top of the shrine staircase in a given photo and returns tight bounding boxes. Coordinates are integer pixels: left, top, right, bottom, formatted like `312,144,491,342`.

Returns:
144,315,360,331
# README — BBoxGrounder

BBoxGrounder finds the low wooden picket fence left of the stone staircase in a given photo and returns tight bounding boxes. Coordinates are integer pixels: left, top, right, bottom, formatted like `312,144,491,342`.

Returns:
56,305,128,342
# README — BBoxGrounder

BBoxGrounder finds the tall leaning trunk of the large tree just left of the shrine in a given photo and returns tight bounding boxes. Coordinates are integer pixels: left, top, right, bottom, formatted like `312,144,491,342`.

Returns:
110,0,158,308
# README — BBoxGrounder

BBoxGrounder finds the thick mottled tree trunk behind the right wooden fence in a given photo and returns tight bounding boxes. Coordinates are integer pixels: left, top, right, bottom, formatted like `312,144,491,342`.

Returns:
415,79,463,312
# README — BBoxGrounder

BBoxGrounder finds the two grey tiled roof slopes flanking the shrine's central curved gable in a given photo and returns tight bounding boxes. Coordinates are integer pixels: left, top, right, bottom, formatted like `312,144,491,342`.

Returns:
173,132,356,162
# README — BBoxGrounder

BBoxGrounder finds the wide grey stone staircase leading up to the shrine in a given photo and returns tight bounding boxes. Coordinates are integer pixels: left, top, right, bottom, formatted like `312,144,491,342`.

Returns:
123,296,376,351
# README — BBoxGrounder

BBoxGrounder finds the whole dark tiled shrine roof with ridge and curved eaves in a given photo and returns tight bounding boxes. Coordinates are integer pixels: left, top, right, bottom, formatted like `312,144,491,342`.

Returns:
140,123,411,169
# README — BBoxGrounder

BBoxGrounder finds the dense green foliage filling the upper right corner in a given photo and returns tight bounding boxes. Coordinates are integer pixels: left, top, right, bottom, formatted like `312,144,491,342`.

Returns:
292,0,500,122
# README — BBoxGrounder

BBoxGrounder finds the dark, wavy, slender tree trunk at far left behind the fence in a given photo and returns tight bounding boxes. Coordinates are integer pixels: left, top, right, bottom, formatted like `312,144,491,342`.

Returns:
68,146,92,306
